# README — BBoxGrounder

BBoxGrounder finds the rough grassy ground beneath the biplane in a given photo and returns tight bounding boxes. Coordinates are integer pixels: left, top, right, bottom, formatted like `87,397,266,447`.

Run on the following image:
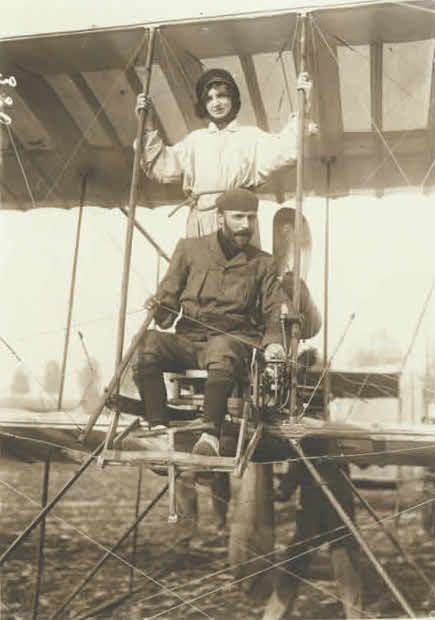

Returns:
0,461,435,620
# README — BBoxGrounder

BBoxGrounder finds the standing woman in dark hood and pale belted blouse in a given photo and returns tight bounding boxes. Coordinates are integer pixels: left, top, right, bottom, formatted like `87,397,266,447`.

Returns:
136,69,311,241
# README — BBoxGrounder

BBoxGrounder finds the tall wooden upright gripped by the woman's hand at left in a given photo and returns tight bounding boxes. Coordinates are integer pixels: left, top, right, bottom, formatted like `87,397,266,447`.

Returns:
99,28,155,448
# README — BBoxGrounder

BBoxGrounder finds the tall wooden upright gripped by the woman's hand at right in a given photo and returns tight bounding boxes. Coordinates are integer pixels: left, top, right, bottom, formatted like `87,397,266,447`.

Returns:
290,14,307,418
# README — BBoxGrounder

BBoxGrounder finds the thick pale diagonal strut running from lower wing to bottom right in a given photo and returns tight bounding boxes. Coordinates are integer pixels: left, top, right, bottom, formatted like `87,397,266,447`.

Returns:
292,441,416,618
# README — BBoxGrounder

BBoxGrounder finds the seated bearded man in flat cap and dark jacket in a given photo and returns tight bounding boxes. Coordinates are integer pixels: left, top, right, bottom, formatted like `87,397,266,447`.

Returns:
134,189,310,456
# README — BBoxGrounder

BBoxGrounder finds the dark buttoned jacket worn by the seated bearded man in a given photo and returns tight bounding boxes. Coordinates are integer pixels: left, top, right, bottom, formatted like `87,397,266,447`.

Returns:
155,233,320,345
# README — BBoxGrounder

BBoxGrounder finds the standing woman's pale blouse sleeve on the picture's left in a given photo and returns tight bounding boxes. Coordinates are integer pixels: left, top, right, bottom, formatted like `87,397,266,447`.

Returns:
140,130,187,183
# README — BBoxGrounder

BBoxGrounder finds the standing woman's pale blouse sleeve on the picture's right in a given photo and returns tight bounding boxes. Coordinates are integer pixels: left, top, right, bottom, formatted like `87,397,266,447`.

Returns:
255,114,297,184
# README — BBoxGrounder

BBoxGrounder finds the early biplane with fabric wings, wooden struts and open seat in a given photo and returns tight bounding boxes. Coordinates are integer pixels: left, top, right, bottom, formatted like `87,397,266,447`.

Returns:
0,0,435,618
